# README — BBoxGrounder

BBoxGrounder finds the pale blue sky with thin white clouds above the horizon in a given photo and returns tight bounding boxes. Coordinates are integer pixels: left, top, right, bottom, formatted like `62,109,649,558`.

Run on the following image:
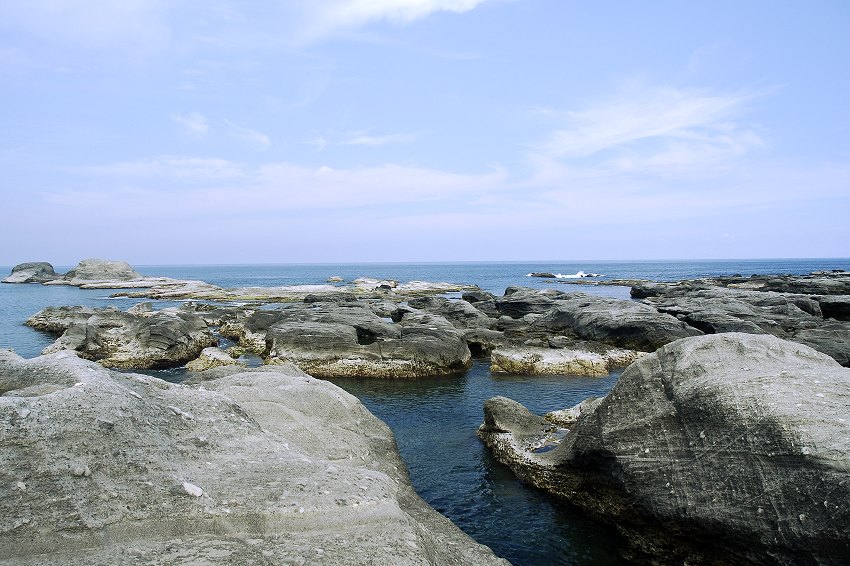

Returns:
0,0,850,265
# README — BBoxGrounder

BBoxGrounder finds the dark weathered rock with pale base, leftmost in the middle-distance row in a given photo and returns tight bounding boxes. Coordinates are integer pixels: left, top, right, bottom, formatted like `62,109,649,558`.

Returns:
44,309,218,369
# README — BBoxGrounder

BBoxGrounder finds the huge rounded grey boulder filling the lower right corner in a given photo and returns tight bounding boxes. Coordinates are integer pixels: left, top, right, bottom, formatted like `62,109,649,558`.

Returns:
479,333,850,564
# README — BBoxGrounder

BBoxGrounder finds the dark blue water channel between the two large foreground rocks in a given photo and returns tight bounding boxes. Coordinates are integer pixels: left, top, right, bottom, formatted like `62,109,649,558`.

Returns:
332,362,624,565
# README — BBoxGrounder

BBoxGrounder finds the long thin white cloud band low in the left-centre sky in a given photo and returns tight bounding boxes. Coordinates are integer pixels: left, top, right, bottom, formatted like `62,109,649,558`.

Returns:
59,156,507,215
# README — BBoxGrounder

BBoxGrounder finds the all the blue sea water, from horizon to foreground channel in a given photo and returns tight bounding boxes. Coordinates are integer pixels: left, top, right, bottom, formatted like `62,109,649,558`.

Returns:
0,259,850,565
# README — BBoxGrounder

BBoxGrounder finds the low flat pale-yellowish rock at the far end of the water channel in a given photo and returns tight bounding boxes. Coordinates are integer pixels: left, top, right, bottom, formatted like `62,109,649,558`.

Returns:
490,347,643,377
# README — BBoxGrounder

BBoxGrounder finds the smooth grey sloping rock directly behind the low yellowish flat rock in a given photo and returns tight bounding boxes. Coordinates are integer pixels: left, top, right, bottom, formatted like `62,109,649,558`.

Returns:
534,293,702,351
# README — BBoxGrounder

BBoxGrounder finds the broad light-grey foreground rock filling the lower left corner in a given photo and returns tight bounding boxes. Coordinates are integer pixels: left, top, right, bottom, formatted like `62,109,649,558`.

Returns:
0,352,507,566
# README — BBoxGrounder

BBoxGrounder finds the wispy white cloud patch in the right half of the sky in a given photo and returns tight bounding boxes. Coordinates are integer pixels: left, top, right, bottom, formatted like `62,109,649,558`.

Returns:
532,85,765,175
